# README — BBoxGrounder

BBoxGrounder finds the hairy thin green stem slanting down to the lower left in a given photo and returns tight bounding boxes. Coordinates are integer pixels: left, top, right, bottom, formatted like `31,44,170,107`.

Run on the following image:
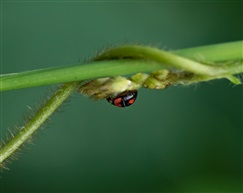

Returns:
0,82,79,166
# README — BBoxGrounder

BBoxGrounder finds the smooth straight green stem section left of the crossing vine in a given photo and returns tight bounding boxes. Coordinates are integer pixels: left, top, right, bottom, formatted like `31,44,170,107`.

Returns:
0,60,162,91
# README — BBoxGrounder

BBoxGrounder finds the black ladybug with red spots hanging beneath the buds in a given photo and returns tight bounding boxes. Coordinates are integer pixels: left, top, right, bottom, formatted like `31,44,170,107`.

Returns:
106,91,138,107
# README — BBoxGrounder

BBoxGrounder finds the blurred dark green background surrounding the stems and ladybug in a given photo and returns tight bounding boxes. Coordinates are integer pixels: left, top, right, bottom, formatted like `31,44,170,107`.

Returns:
0,1,243,192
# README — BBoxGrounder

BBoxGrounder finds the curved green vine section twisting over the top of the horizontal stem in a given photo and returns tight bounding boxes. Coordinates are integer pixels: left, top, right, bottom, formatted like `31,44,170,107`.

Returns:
94,46,242,76
